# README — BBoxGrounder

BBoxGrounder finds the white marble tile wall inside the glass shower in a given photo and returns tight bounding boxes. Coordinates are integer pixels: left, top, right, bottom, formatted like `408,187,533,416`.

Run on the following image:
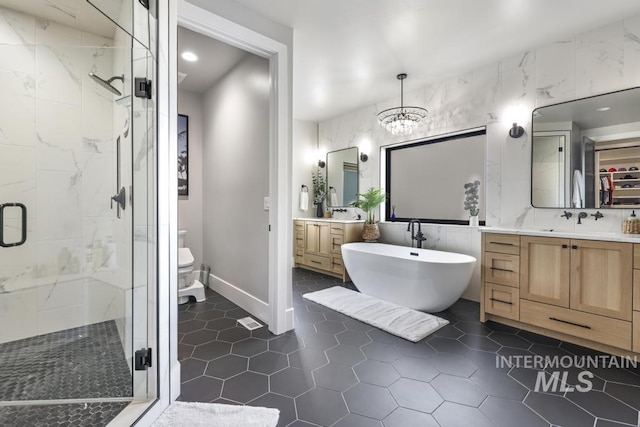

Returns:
0,8,131,342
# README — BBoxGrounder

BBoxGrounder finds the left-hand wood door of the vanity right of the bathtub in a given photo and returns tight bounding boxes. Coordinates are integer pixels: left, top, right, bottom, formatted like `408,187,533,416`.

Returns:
520,236,571,307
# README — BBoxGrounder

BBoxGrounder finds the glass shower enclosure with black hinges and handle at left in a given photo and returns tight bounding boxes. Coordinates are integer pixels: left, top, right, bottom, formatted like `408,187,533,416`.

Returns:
0,0,157,425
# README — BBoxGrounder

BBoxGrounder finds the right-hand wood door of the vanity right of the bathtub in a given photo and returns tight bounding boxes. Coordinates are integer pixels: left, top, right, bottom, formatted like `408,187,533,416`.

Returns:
571,240,633,320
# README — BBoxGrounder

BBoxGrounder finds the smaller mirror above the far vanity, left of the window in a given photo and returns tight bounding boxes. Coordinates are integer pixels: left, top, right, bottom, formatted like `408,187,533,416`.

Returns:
327,147,358,208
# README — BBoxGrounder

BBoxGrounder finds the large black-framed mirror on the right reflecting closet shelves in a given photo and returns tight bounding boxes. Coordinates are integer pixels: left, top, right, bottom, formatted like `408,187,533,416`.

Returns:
531,88,640,209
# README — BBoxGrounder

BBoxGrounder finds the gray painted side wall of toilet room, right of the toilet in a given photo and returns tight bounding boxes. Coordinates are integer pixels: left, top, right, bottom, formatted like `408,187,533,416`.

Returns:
202,55,269,302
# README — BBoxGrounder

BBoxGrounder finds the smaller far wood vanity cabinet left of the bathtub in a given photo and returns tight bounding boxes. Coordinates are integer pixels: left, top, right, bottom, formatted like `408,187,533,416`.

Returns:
293,220,362,282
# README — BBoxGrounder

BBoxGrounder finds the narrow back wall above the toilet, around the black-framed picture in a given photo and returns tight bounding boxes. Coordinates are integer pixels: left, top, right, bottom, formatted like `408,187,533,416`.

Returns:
178,90,203,270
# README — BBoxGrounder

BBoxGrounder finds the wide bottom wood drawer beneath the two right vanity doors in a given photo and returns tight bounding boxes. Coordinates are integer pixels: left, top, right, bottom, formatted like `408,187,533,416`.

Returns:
520,300,631,350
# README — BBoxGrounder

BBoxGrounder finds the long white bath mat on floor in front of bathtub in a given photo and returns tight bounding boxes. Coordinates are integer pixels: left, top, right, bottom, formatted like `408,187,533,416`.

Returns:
302,286,449,342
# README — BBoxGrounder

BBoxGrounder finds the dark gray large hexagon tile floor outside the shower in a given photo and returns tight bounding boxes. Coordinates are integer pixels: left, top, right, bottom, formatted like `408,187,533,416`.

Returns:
178,269,640,427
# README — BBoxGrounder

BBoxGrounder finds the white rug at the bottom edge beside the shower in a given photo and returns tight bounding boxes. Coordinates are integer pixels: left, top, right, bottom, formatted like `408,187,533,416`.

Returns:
152,402,280,427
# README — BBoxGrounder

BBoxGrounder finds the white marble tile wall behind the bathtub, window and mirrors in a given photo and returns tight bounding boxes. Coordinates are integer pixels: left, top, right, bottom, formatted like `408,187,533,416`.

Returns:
320,16,640,299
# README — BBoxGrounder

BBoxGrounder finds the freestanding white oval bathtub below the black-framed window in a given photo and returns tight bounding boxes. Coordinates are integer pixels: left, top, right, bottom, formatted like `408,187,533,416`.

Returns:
342,243,476,313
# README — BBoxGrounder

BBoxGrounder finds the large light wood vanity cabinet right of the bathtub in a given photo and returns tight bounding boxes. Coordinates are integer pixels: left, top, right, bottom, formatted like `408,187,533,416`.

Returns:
480,233,640,351
